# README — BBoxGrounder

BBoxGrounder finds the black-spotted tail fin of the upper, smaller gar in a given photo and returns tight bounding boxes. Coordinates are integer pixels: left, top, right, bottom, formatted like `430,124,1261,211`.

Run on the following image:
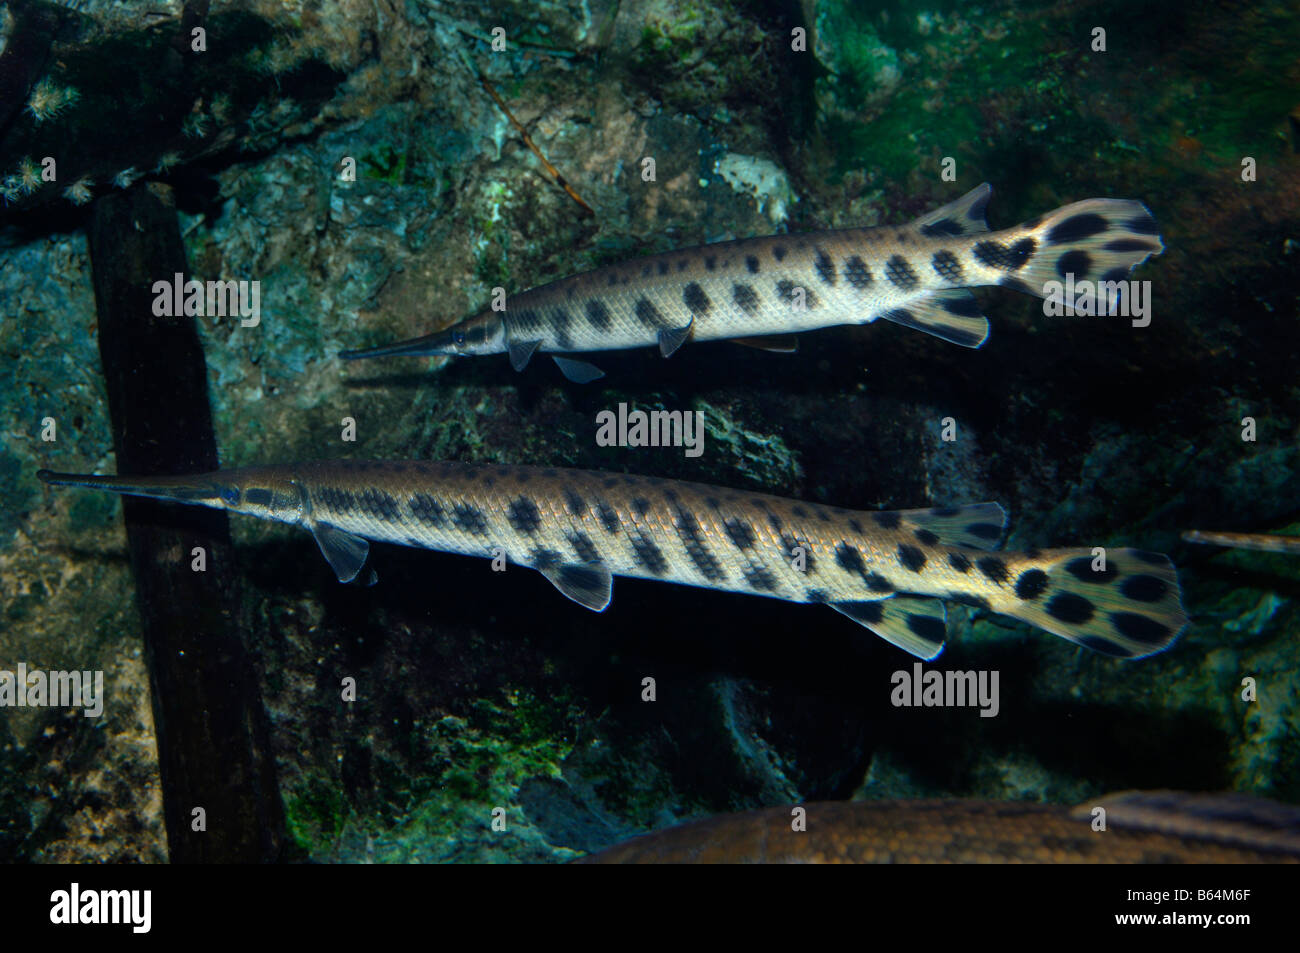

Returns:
998,199,1165,298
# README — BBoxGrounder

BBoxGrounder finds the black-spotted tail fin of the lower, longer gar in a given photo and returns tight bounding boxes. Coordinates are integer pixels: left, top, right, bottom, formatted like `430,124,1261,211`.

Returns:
996,549,1187,658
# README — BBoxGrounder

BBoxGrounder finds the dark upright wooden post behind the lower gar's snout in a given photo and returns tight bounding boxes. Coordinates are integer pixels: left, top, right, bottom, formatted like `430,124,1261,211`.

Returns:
88,186,285,863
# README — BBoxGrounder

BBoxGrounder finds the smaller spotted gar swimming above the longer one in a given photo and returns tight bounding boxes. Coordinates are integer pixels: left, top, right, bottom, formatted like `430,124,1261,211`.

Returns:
341,183,1165,381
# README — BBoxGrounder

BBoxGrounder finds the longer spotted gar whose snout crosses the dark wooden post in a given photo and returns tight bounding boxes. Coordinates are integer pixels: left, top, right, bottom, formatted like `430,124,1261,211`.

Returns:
38,460,1187,659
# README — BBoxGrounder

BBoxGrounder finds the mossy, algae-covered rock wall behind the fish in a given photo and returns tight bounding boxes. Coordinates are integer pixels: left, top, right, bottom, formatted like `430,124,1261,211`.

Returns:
0,0,1300,862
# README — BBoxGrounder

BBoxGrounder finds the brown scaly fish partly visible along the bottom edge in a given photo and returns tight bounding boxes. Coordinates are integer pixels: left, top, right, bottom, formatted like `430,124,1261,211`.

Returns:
577,790,1300,863
